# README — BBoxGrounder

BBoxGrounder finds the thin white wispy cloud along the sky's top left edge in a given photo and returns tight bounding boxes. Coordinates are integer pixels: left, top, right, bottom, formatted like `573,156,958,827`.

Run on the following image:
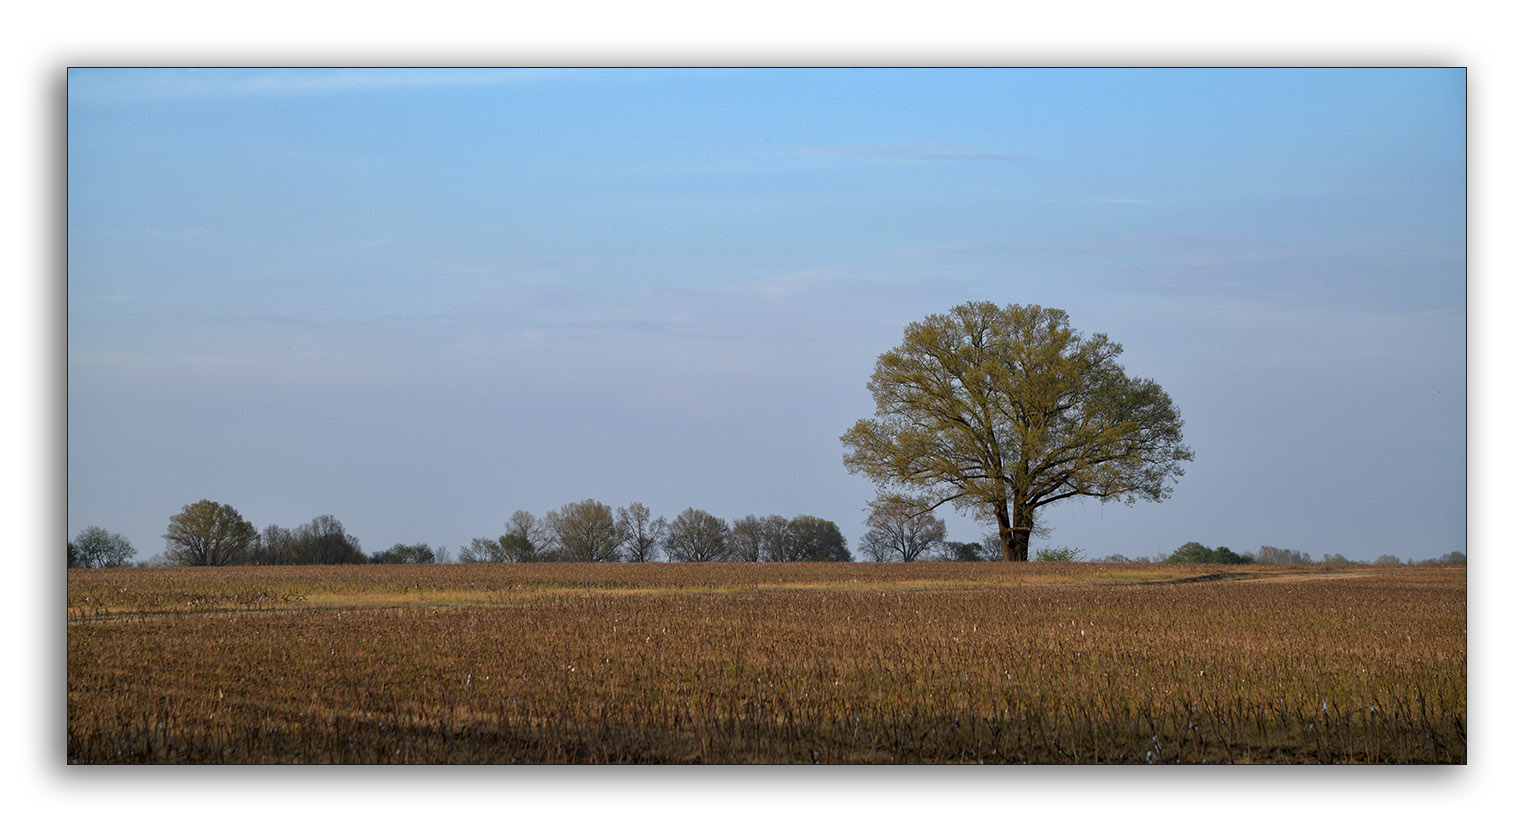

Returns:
69,69,571,100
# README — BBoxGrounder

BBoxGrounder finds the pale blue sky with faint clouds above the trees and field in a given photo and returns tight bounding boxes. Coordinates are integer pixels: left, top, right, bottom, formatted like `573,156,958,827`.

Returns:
67,69,1467,559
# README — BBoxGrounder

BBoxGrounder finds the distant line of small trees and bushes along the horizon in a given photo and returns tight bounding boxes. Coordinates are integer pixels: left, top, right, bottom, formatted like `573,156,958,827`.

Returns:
67,499,1467,568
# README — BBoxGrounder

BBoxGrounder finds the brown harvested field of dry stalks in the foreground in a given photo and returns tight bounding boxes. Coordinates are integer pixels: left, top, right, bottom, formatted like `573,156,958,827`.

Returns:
67,563,1467,763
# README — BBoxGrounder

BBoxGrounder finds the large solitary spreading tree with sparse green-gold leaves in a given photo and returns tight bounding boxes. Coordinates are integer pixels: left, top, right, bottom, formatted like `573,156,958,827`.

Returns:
842,301,1193,560
